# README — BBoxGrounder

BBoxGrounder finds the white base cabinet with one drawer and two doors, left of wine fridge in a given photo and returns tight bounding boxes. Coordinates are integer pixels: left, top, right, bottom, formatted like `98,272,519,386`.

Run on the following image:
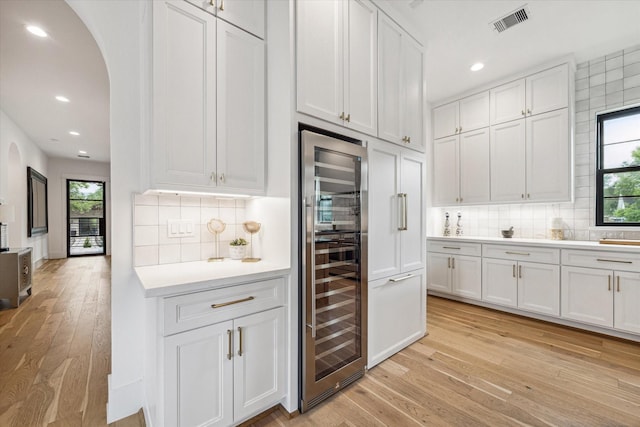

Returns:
158,278,287,427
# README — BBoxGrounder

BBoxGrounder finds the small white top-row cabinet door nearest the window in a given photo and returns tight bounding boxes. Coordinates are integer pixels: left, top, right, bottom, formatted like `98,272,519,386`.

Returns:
526,64,569,116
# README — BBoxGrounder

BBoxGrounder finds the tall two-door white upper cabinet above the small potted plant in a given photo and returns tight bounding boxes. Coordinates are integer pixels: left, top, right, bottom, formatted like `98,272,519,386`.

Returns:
150,0,265,194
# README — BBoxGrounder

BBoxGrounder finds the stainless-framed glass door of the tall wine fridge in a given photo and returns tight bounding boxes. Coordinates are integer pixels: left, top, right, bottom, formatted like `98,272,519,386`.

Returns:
301,130,367,411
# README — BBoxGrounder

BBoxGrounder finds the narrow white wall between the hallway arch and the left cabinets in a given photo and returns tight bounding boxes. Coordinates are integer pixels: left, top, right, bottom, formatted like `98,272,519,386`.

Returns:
67,0,151,422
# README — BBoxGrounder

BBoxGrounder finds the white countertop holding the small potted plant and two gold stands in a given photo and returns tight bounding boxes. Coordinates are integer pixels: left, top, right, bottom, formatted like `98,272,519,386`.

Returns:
135,258,291,297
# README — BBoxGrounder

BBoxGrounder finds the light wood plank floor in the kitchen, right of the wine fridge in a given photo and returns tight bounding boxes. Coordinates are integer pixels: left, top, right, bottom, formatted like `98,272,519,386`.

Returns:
252,297,640,427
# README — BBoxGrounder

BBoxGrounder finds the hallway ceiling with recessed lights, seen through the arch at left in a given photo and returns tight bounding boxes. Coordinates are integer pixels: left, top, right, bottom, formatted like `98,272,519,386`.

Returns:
0,0,110,162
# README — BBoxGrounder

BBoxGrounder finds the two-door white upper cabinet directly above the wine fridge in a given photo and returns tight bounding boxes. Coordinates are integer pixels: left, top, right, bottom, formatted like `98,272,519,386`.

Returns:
297,0,377,135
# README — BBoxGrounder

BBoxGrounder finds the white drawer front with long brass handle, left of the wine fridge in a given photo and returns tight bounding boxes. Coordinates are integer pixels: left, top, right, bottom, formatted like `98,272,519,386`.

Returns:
162,277,285,336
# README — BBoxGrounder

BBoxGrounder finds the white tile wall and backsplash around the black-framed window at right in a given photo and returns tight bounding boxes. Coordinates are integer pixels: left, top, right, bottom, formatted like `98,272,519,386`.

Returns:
429,44,640,244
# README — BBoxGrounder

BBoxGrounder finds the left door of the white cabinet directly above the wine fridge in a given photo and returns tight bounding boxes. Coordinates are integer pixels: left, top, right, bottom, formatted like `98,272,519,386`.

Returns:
296,0,344,125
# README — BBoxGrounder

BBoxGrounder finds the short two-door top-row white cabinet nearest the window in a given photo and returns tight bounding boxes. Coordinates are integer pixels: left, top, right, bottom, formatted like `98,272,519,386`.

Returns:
491,64,569,125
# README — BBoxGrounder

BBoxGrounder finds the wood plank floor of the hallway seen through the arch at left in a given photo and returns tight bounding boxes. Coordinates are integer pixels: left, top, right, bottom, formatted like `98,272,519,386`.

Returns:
0,257,144,427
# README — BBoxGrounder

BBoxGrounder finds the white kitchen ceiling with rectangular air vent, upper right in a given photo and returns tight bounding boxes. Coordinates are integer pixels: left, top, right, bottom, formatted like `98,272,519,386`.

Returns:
389,0,640,103
